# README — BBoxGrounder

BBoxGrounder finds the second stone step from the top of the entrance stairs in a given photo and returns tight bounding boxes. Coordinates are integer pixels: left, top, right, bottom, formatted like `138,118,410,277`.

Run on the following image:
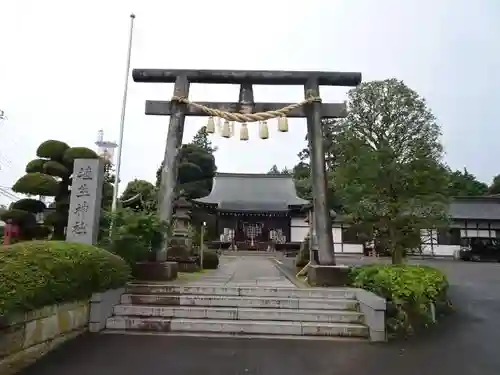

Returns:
121,293,358,311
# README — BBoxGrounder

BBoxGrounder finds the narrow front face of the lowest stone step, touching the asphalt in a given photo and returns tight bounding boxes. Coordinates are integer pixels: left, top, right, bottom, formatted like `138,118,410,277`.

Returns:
100,328,368,342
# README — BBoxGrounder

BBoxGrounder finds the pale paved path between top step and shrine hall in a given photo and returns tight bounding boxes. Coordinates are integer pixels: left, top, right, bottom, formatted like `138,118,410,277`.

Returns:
188,255,295,287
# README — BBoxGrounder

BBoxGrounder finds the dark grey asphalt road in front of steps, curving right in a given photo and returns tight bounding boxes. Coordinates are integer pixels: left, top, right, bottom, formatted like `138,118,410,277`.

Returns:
18,258,500,375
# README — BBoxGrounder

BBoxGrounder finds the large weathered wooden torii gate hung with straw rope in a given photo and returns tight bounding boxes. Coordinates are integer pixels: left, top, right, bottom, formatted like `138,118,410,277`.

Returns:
132,69,361,265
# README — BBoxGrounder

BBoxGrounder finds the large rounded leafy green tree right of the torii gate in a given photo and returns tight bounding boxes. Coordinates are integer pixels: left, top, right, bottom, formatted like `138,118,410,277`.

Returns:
334,79,448,263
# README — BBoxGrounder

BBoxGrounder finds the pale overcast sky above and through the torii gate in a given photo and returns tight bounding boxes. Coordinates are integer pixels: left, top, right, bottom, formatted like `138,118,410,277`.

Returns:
0,0,500,203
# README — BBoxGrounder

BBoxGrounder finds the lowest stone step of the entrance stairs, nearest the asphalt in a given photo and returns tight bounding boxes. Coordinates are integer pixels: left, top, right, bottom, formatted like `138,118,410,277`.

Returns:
106,316,369,338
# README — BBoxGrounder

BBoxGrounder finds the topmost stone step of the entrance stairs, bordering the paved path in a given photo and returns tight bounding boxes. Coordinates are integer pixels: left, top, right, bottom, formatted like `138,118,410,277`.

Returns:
127,281,356,299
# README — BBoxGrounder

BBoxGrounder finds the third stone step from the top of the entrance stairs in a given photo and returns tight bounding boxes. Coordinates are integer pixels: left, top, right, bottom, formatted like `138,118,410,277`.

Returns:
114,305,363,324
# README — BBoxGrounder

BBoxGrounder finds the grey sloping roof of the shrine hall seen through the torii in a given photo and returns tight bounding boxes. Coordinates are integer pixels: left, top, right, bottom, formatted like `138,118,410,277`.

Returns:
194,173,309,212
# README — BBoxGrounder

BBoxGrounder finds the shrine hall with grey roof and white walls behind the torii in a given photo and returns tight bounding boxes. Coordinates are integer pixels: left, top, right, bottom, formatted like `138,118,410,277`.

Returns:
193,173,363,253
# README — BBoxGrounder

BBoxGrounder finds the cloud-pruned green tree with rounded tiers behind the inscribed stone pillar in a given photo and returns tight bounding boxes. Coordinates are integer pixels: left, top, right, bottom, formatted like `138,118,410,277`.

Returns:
3,140,98,239
